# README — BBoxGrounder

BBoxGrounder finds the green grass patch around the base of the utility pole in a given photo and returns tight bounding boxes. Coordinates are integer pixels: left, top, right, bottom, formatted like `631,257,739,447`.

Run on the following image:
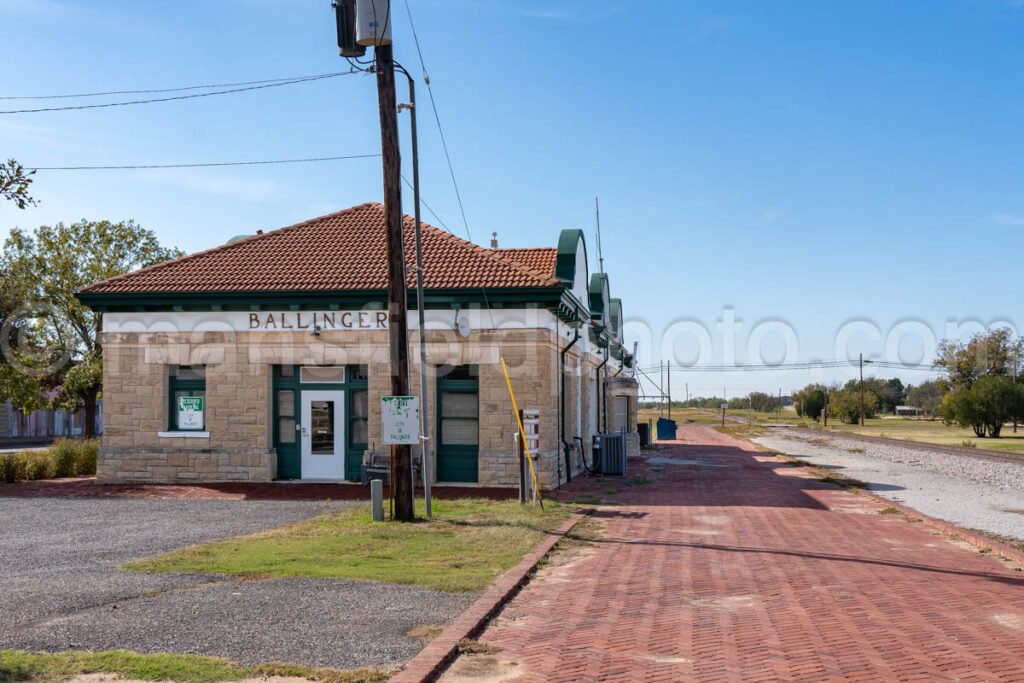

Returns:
124,499,571,592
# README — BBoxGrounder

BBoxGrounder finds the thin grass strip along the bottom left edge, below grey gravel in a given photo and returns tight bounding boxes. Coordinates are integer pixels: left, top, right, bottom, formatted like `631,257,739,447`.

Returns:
0,650,388,683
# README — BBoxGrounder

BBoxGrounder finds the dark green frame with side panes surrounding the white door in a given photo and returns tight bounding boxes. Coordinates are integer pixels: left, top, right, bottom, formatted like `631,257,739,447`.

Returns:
271,366,370,481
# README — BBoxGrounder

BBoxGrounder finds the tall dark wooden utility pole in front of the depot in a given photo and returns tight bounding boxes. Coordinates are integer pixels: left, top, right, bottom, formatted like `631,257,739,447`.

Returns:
374,44,413,521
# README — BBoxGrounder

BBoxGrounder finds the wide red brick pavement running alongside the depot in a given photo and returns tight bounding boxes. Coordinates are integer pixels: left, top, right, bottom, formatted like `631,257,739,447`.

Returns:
446,426,1024,681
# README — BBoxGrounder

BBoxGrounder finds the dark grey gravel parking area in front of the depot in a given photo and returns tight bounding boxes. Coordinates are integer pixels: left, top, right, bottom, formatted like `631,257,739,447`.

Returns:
0,498,475,668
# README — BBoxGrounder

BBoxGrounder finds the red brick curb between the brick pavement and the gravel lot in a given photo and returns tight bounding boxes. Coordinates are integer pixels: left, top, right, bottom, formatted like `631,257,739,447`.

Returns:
389,513,588,683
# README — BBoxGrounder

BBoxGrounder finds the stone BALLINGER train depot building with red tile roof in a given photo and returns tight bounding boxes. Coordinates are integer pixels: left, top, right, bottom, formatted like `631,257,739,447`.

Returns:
79,204,639,488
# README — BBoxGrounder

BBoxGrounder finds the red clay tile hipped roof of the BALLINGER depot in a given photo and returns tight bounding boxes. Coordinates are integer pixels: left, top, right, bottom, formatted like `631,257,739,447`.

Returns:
82,203,559,294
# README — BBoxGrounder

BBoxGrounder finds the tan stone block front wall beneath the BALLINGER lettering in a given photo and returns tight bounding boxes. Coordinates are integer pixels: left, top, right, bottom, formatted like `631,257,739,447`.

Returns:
98,329,560,487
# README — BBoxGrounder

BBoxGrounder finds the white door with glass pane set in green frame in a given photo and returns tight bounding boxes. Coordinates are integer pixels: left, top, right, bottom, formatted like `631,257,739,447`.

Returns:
301,391,345,481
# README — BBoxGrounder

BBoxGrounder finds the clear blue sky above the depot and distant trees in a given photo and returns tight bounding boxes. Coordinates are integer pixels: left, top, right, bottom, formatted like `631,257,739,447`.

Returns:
0,0,1024,395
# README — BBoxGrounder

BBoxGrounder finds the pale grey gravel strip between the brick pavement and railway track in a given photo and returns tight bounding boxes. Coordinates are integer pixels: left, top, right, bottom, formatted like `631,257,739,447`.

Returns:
753,429,1024,542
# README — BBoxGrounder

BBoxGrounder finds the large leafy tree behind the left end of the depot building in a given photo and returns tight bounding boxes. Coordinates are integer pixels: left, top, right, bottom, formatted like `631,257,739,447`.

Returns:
0,220,181,436
